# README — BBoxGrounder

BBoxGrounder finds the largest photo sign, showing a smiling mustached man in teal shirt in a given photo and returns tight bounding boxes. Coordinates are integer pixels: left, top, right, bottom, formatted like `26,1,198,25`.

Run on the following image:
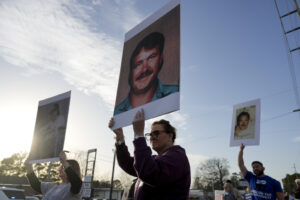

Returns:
113,1,180,129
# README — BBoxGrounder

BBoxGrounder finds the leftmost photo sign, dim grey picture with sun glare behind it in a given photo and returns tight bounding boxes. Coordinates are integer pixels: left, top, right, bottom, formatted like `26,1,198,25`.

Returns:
29,91,71,163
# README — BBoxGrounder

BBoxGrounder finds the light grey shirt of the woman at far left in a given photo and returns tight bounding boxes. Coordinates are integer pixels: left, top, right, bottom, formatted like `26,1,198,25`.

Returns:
41,182,80,200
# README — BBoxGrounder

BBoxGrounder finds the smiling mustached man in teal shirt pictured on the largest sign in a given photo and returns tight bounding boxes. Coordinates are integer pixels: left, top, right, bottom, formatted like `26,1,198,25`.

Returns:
114,32,179,115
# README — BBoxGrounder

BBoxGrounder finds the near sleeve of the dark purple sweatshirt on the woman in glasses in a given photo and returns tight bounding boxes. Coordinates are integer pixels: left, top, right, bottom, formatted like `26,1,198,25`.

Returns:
133,138,190,186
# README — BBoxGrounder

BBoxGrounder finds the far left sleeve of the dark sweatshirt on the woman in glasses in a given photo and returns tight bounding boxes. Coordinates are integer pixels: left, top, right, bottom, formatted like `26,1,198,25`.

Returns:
116,143,137,177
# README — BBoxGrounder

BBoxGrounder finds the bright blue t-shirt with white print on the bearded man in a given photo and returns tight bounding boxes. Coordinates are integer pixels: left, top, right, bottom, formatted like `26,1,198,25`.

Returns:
245,171,282,200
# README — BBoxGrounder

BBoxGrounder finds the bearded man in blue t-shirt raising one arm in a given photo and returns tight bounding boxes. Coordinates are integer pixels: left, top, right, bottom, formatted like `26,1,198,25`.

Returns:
238,144,283,200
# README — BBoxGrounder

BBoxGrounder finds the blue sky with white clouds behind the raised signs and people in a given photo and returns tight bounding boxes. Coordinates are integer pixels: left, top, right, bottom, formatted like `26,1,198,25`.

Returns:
0,0,300,184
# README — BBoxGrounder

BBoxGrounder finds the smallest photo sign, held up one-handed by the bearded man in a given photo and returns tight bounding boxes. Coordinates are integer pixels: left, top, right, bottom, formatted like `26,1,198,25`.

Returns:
230,99,260,146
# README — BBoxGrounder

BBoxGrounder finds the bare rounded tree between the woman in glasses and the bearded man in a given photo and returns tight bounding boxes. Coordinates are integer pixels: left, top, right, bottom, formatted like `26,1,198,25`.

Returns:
193,158,229,192
